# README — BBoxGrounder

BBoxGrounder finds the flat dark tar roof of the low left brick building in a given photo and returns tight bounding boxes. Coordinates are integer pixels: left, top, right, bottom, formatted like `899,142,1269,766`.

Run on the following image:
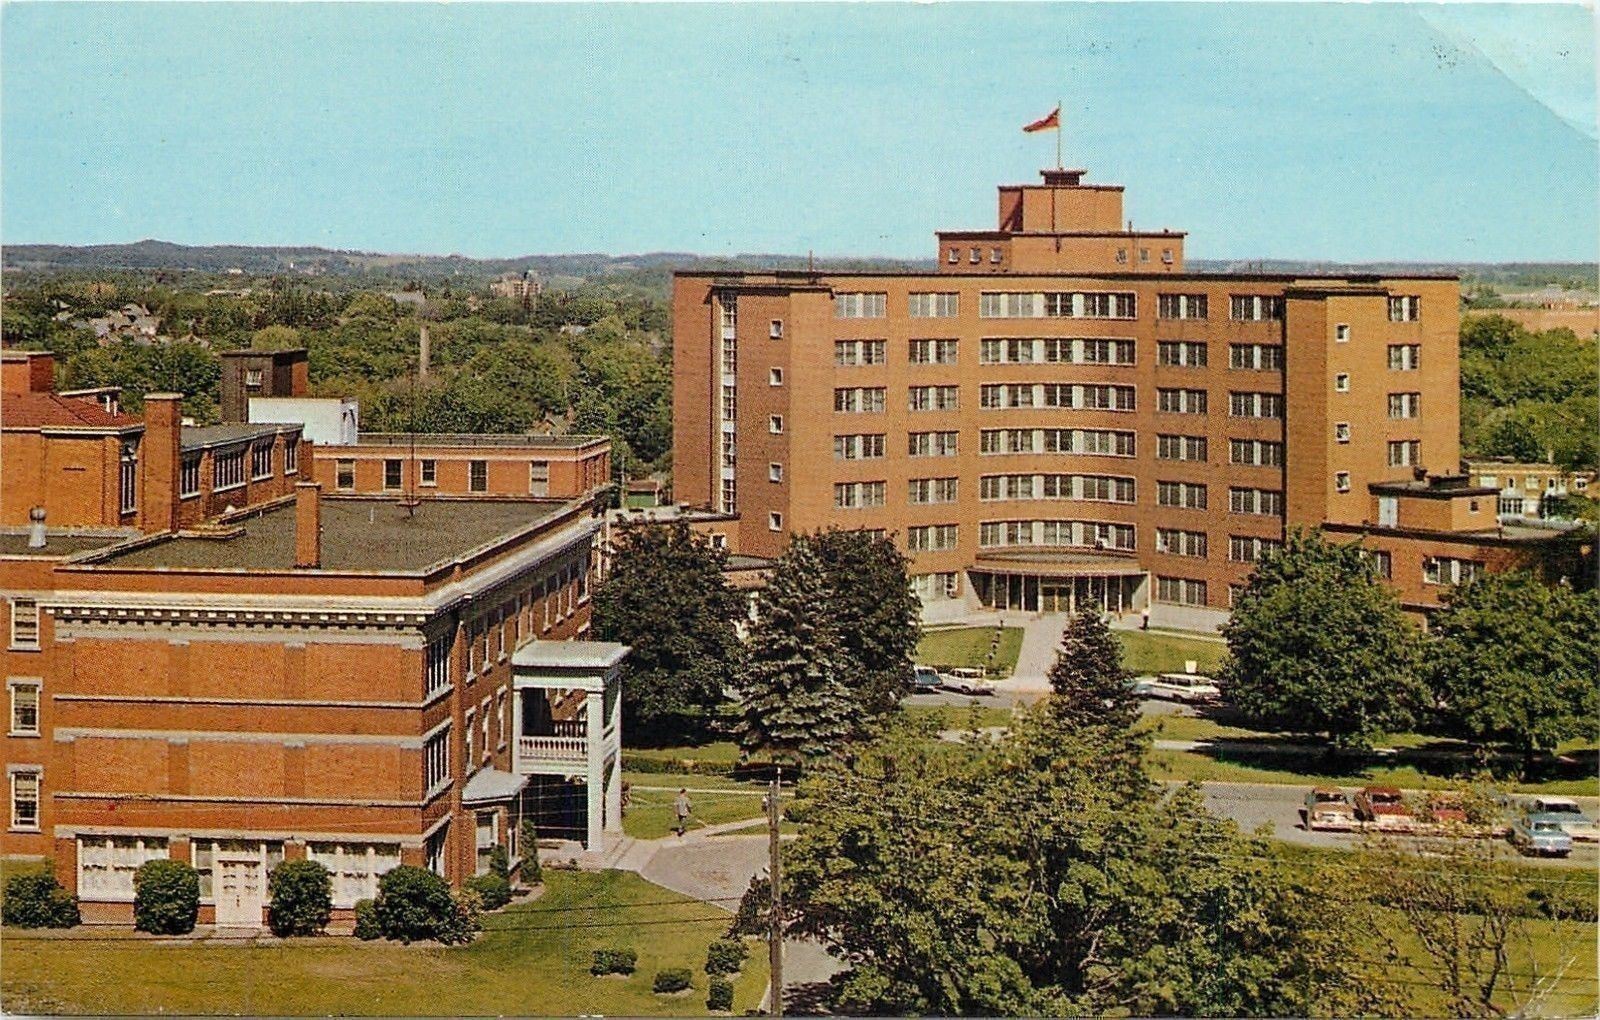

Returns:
96,497,566,574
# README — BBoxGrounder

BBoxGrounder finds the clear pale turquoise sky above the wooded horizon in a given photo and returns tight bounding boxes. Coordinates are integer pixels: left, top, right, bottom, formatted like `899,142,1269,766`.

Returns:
0,2,1600,262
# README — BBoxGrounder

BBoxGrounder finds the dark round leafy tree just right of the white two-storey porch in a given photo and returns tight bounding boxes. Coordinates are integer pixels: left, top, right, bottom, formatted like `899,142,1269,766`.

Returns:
594,521,746,740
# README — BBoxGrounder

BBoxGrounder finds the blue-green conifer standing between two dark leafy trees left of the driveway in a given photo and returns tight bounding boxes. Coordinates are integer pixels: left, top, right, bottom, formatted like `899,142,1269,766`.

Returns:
736,536,861,761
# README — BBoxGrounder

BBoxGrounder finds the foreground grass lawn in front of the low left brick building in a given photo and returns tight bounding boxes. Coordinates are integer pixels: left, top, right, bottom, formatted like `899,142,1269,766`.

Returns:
0,871,766,1017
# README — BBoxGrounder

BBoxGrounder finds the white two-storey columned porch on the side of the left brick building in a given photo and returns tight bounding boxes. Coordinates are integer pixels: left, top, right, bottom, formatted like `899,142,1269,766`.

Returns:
510,641,629,851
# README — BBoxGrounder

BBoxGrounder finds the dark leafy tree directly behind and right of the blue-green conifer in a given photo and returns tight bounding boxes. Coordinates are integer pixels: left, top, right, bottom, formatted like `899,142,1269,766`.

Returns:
811,529,922,718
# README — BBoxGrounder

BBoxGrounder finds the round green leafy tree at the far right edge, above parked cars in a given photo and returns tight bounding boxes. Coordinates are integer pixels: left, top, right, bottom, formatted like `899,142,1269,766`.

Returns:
1429,572,1600,758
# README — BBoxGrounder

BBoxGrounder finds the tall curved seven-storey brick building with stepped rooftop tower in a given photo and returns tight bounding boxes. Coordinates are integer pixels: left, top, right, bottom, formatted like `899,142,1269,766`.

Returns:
674,171,1587,627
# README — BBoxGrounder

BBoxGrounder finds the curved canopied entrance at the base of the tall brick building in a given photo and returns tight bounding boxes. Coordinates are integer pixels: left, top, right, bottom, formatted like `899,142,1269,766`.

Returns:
968,552,1150,614
